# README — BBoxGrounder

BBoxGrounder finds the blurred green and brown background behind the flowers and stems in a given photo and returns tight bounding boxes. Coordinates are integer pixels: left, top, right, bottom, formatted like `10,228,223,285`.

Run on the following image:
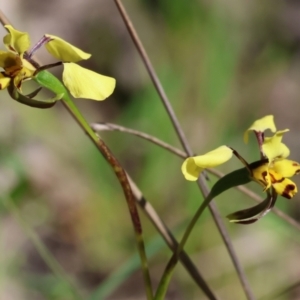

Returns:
0,0,300,300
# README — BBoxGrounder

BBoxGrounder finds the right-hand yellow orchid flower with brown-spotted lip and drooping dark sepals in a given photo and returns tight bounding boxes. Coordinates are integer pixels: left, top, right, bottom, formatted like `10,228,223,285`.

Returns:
181,115,300,224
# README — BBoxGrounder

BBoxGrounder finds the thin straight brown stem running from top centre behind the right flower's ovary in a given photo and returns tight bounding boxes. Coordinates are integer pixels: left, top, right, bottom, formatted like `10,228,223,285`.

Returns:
115,0,255,300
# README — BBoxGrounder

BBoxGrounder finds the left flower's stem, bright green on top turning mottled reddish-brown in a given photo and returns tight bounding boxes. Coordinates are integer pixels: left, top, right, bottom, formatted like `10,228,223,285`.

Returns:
35,71,153,300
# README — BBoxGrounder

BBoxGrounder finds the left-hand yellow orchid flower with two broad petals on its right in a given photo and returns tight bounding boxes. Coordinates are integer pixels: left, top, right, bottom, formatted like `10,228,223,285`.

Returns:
0,25,116,100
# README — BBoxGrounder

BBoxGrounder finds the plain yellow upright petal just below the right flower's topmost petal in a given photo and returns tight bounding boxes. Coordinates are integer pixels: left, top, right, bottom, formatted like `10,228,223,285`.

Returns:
262,129,290,162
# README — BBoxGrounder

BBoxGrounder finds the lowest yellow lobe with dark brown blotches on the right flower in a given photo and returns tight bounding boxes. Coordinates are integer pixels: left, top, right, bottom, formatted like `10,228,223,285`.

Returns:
269,170,298,199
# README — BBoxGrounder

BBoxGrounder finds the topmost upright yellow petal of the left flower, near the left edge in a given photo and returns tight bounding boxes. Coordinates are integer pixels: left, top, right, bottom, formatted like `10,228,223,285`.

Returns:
3,25,30,56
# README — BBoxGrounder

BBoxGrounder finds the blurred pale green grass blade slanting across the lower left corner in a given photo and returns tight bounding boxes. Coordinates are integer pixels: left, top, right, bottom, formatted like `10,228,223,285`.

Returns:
1,195,83,300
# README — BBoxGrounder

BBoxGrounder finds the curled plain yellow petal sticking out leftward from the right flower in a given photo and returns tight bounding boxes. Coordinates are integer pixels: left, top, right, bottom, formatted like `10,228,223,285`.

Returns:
181,146,232,181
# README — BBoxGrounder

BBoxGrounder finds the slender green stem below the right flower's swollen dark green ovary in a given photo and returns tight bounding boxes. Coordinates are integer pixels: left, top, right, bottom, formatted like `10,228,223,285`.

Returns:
154,194,213,300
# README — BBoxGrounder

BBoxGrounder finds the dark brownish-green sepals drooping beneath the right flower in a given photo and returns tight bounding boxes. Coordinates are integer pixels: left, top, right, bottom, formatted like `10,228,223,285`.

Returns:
227,194,277,224
